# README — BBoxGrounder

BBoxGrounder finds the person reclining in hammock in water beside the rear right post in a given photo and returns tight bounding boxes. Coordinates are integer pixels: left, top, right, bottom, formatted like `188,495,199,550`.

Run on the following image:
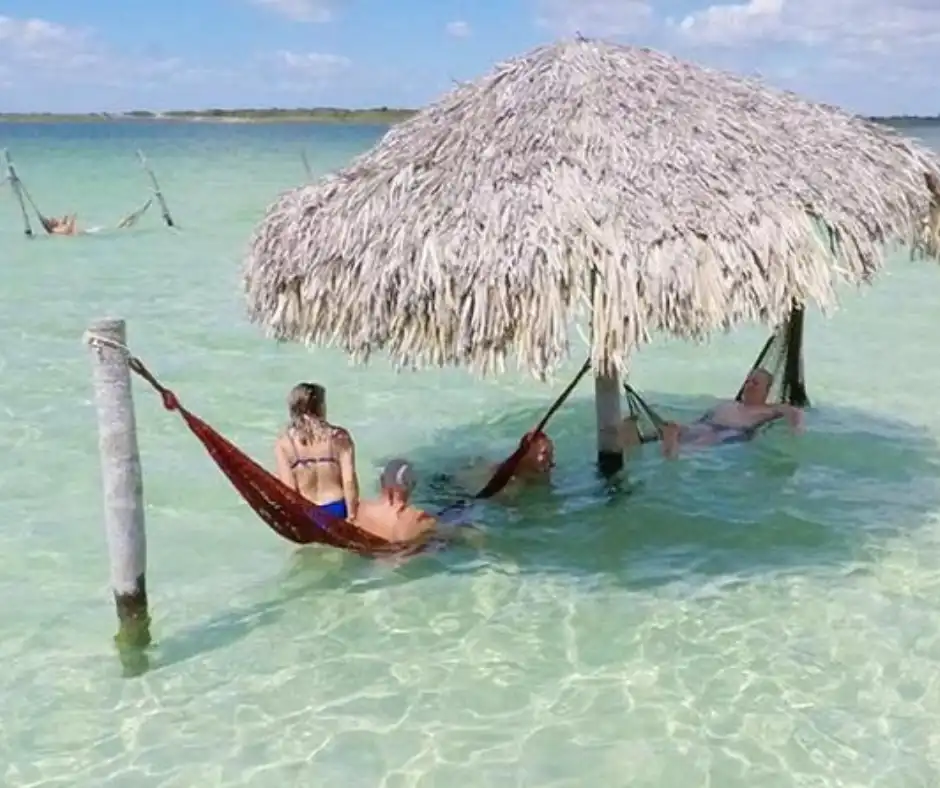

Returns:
621,368,803,459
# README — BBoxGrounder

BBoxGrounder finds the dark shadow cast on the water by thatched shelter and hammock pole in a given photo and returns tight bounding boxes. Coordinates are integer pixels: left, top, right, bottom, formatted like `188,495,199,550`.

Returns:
140,395,940,669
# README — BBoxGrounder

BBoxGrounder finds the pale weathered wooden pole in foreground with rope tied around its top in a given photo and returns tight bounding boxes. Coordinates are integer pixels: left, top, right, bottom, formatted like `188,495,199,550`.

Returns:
85,318,150,648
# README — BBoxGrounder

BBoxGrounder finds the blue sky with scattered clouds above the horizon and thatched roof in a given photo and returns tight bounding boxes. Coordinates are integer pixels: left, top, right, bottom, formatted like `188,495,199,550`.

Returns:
0,0,940,115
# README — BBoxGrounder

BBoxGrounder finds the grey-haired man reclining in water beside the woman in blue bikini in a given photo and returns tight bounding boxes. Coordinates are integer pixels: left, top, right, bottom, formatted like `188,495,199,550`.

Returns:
355,459,480,542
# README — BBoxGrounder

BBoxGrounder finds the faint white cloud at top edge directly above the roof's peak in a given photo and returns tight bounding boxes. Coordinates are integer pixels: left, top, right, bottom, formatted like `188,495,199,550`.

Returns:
535,0,653,36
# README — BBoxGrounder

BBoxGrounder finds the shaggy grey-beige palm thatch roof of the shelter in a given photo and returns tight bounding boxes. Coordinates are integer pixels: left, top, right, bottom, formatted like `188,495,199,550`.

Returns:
244,38,940,376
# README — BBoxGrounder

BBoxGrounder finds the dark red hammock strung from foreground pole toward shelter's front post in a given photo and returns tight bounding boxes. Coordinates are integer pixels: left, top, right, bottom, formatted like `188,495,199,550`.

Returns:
128,356,589,556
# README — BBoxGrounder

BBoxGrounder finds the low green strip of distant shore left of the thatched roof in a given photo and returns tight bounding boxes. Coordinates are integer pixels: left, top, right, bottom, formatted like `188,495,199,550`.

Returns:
0,107,415,125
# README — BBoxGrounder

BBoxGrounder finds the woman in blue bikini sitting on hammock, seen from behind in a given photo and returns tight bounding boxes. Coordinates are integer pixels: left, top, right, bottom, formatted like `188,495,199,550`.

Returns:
274,383,359,520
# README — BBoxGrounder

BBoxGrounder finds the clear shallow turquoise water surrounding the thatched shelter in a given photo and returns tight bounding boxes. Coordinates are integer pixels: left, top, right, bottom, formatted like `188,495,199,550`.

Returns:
0,118,940,788
